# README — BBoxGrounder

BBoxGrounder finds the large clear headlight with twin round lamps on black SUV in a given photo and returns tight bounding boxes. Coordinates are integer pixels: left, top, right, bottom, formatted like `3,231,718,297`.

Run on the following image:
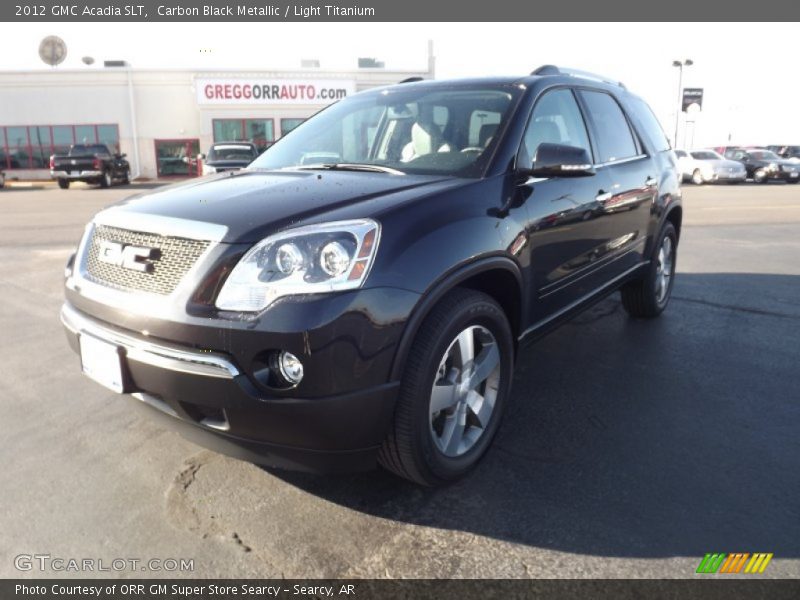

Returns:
216,219,380,312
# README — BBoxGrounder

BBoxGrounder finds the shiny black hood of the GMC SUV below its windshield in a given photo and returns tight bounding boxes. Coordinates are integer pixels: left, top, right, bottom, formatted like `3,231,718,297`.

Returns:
99,170,460,243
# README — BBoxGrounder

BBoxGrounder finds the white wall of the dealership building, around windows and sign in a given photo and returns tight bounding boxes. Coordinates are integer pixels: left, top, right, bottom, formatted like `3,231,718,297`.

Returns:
0,61,433,179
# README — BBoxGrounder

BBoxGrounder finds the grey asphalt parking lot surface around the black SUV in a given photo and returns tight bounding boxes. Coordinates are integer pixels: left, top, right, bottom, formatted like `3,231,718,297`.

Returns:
0,184,800,578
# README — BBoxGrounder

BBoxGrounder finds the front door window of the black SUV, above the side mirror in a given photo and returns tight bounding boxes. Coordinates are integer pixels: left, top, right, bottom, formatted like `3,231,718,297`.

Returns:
518,89,592,166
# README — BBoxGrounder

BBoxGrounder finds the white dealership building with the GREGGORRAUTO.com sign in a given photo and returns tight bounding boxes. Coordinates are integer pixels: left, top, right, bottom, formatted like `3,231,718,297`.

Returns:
0,51,434,179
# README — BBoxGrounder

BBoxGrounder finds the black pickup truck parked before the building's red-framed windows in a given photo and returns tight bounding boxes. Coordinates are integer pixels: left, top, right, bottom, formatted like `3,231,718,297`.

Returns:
50,144,131,190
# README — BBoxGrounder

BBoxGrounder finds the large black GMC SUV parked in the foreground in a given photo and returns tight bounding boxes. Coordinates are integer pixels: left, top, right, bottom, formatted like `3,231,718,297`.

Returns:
61,66,682,485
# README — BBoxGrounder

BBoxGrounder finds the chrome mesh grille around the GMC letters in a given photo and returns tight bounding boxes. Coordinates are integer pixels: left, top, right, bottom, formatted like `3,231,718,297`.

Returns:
86,225,209,295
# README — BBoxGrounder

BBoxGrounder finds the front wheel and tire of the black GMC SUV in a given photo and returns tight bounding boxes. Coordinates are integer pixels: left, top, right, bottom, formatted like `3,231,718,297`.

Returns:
378,288,514,486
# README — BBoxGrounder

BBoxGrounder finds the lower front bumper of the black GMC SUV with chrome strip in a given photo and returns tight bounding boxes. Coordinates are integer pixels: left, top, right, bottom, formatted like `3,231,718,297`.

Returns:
61,303,399,471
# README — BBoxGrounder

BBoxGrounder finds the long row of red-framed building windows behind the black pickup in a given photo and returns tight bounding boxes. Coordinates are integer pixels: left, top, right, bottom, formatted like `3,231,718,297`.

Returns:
0,124,119,169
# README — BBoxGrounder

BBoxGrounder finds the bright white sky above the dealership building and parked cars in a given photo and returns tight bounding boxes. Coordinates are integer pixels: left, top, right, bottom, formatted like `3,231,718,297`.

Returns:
0,23,800,148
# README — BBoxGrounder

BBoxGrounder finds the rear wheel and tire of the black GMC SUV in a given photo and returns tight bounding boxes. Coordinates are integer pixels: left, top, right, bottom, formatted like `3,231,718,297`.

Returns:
621,221,678,319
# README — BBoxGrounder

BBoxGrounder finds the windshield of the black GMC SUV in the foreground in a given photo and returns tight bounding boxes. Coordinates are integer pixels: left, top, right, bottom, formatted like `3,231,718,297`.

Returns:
250,85,522,177
